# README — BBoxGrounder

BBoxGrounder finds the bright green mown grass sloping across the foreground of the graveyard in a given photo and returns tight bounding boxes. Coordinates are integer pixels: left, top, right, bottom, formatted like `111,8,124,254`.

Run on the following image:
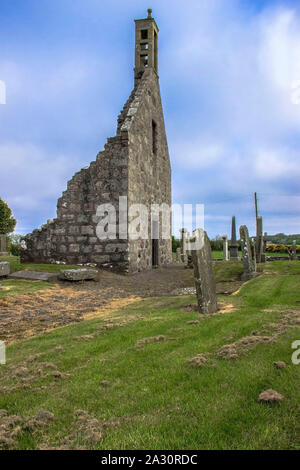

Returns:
0,262,300,449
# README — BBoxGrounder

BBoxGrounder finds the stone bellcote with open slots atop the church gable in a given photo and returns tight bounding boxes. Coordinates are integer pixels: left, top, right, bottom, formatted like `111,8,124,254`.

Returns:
134,8,159,84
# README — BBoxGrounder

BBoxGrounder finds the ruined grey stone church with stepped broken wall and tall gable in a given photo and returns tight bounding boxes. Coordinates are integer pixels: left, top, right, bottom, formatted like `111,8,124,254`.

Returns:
21,10,172,273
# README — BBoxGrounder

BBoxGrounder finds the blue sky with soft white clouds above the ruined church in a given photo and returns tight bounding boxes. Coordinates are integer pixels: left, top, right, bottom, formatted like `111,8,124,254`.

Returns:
0,0,300,237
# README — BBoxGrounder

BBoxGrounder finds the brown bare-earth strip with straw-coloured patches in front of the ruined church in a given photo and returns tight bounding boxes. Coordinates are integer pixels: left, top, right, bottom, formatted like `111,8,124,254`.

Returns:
0,264,241,344
